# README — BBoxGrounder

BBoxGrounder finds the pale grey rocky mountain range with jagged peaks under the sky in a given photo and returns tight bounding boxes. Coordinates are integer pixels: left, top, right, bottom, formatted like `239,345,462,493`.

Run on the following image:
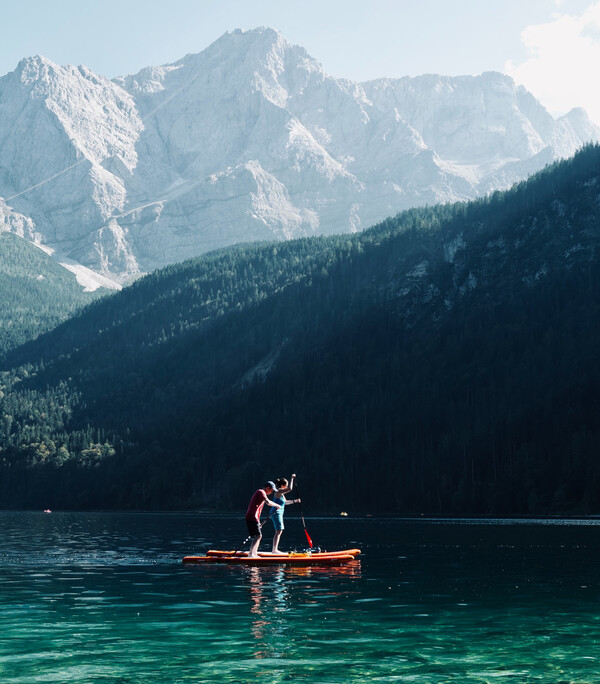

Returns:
0,29,600,281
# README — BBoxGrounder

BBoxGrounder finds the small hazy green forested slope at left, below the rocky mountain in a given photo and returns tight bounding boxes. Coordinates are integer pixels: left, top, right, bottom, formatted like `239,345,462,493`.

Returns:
0,232,104,356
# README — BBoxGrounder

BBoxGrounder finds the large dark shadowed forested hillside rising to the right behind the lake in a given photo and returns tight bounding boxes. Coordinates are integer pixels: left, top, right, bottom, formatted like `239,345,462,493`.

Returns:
0,145,600,514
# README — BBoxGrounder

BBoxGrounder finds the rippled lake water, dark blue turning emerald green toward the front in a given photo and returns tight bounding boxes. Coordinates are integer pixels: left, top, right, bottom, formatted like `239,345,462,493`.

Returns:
0,512,600,684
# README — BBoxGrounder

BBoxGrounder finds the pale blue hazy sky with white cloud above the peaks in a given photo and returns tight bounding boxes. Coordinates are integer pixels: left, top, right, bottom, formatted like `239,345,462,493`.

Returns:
0,0,600,124
